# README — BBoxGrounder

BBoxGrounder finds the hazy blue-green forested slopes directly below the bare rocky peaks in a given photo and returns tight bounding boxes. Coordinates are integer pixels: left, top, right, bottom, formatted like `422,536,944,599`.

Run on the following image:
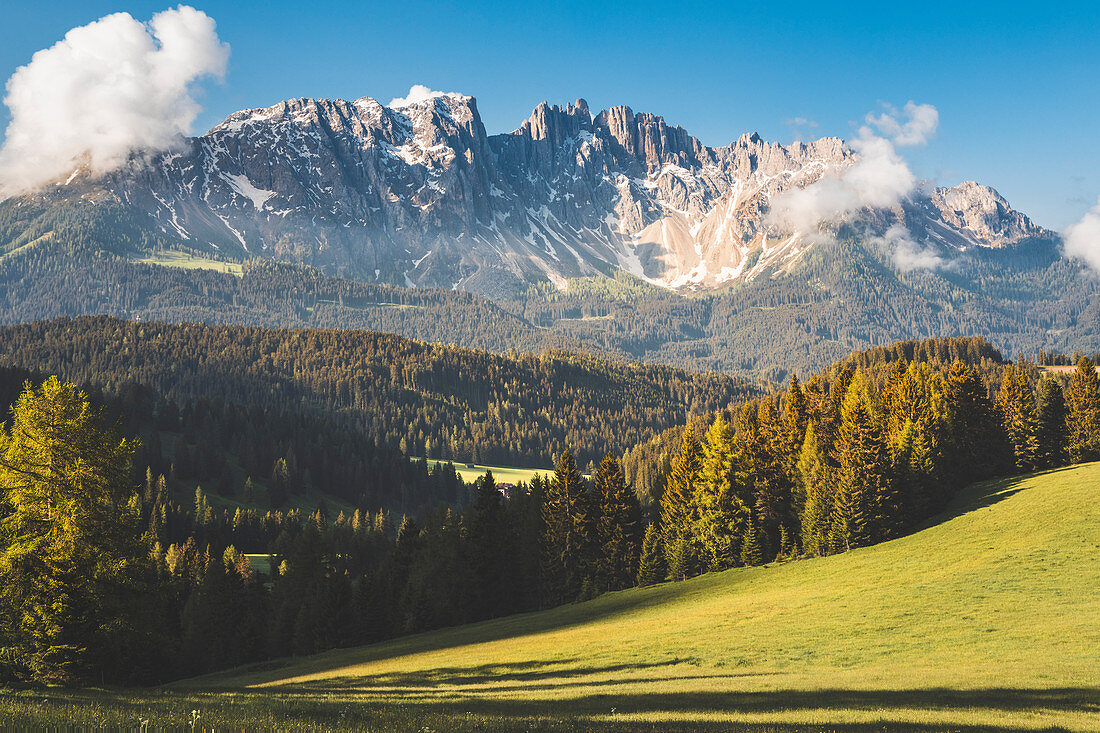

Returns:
0,204,1100,381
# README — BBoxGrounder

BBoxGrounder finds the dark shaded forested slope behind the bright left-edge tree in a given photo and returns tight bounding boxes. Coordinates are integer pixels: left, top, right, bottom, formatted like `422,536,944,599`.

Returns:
0,368,466,512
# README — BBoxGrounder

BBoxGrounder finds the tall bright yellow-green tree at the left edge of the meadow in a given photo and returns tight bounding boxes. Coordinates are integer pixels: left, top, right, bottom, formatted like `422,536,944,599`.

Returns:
0,376,155,682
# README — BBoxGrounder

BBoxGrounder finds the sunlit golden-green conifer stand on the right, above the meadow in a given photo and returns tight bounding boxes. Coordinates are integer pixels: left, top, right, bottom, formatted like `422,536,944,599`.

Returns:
626,339,1100,581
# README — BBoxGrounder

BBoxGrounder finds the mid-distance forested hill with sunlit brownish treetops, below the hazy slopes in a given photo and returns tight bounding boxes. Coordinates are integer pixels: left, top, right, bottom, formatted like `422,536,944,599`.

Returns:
0,317,756,467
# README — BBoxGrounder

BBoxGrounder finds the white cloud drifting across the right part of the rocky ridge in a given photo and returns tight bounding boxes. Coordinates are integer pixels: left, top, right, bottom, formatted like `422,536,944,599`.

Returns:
768,102,939,236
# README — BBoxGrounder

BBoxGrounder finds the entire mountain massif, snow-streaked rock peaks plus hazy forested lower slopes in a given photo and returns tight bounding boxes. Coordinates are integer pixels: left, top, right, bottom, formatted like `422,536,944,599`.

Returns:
0,94,1100,380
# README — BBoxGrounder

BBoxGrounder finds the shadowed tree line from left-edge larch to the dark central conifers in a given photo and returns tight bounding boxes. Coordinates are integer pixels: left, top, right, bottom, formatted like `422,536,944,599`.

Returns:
0,376,640,683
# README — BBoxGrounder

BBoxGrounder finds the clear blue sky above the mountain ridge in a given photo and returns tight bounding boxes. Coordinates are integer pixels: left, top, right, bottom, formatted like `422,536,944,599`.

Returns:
0,0,1100,228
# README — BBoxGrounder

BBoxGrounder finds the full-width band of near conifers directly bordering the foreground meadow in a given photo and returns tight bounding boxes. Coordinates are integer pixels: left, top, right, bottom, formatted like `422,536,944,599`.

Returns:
0,339,1100,682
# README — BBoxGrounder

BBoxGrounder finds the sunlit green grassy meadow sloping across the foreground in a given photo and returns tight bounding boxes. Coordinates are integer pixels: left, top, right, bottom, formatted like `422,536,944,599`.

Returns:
0,463,1100,731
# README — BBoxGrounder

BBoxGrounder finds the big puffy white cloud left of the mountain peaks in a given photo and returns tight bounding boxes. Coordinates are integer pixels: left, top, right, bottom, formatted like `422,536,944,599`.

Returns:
0,6,229,198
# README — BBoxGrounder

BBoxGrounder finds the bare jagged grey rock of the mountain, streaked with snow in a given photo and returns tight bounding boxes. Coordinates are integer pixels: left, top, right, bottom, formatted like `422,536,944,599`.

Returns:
19,94,1053,295
